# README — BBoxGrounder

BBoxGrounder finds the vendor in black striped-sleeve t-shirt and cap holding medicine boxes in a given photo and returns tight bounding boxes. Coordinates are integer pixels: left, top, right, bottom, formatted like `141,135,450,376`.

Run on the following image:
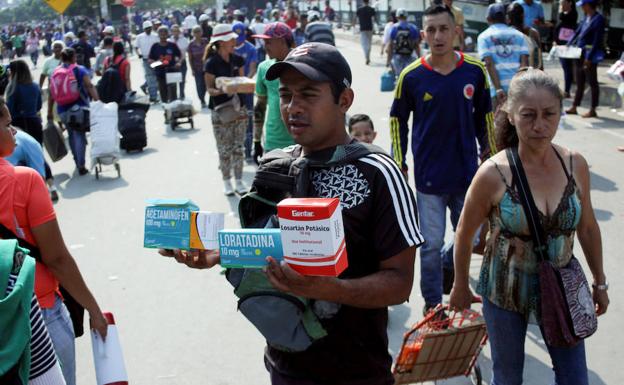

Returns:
161,43,423,385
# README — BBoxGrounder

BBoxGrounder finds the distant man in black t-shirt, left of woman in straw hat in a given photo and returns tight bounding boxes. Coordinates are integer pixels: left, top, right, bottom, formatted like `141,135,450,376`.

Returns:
148,25,182,103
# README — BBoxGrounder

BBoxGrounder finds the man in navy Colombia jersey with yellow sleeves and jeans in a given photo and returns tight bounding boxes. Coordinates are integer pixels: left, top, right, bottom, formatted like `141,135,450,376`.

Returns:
390,5,496,310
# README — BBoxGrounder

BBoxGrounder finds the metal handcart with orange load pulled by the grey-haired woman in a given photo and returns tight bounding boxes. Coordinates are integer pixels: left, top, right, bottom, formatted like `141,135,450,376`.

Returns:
393,305,487,385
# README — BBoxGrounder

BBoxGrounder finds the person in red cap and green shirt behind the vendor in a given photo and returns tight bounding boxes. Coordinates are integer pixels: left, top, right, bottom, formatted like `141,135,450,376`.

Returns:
253,21,295,163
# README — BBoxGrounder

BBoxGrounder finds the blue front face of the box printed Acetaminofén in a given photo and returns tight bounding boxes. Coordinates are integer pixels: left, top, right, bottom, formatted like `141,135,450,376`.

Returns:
143,199,199,250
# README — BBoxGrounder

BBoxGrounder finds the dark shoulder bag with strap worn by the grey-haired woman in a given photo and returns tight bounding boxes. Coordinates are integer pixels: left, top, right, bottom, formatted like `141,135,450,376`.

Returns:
506,147,598,347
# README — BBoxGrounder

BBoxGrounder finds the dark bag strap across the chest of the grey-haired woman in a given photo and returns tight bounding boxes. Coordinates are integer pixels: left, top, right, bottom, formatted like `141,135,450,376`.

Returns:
506,147,548,262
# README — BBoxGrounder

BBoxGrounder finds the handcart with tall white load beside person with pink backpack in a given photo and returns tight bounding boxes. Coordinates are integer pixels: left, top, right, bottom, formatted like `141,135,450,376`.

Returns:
89,101,121,179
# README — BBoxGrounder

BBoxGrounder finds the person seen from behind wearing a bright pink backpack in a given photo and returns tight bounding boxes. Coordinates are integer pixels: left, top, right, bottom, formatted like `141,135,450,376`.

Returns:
51,48,98,175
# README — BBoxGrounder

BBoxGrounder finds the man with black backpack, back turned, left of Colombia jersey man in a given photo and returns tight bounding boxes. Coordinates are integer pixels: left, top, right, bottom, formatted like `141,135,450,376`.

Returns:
386,8,420,76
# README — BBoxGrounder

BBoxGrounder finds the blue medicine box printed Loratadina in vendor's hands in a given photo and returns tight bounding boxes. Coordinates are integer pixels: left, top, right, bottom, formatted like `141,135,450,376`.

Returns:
219,229,283,268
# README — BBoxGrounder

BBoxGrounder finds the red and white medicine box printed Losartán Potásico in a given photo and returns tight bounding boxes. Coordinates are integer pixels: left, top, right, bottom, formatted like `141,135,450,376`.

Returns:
277,198,348,277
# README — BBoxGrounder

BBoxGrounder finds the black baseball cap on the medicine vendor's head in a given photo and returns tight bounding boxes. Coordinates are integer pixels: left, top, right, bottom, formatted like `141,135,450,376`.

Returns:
266,43,352,90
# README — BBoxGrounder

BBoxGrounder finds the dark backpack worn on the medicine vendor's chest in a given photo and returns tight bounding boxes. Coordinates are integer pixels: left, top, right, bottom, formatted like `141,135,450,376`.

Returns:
226,142,385,352
